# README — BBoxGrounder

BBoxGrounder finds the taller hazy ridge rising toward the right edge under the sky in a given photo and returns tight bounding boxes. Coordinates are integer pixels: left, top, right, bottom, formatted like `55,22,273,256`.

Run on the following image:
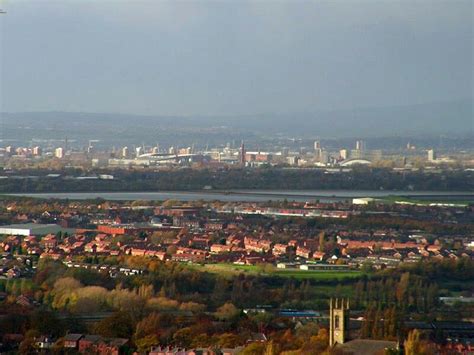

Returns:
244,101,474,137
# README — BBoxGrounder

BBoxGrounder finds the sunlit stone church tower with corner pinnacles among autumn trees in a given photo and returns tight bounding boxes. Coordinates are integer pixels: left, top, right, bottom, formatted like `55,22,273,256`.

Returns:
329,298,349,346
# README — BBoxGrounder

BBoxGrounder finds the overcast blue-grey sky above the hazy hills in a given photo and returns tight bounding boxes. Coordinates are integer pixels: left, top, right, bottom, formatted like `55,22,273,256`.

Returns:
0,0,473,116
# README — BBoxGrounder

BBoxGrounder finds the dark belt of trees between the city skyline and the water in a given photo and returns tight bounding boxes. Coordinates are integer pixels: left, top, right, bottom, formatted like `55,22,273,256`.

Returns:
0,167,474,192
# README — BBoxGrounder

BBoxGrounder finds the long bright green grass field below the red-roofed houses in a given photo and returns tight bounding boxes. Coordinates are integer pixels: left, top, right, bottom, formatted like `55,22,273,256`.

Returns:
185,263,362,280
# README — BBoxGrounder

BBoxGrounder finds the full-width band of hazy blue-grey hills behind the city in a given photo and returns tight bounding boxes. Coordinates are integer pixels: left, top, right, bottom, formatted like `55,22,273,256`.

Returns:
2,100,474,144
